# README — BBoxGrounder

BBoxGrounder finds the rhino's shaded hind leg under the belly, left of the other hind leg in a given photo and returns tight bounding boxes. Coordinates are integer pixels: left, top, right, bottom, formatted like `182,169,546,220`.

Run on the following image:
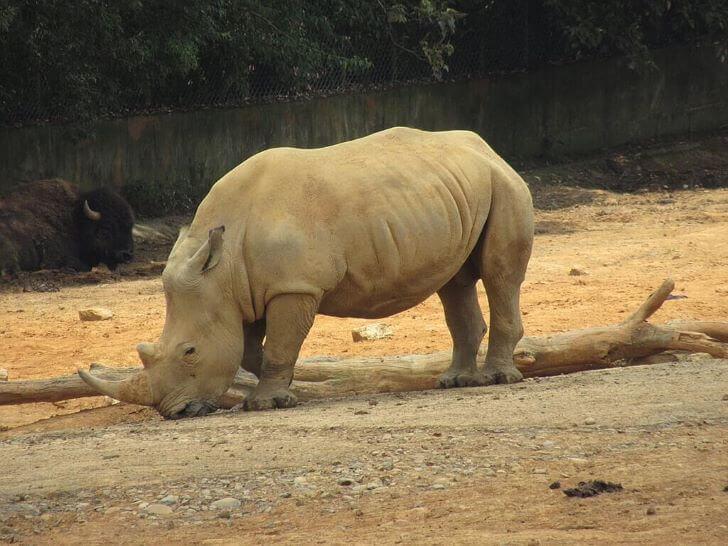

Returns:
437,270,487,389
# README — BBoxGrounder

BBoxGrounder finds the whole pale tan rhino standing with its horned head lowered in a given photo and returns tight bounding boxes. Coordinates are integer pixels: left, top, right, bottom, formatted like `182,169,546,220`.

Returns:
79,128,533,418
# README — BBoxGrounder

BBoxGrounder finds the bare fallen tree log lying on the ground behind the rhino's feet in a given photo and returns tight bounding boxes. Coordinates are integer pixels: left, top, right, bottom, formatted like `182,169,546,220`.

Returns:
0,279,728,408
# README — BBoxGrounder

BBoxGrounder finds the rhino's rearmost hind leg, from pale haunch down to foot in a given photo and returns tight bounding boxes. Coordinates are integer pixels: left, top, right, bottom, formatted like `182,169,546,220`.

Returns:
480,178,533,385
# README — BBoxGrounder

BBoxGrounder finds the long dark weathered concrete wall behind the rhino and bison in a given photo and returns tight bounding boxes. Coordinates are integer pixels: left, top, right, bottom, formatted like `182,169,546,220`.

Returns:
0,44,728,213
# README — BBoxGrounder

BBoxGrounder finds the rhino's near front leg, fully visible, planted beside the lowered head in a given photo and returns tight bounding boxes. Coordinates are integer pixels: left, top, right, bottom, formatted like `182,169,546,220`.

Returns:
243,294,318,411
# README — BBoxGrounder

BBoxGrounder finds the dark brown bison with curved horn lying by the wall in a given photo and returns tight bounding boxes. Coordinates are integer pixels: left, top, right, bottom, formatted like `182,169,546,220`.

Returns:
0,180,134,275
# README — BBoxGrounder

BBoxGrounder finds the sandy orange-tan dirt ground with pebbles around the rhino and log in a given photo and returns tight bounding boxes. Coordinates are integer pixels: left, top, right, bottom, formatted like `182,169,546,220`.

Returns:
0,131,728,544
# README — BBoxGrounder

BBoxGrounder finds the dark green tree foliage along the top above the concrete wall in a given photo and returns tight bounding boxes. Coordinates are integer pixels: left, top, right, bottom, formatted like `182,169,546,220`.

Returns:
0,0,728,124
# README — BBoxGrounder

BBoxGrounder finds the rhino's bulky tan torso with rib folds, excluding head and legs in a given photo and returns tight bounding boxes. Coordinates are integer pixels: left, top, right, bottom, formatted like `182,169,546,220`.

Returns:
232,129,493,316
